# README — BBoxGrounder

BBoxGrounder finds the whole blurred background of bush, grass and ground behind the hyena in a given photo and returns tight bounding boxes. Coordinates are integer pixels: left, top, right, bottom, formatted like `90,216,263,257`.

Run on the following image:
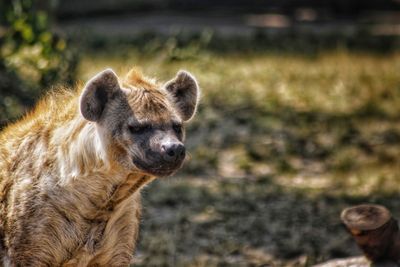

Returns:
0,0,400,266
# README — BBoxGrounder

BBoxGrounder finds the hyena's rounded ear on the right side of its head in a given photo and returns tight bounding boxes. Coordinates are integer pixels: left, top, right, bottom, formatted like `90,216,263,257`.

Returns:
165,70,200,121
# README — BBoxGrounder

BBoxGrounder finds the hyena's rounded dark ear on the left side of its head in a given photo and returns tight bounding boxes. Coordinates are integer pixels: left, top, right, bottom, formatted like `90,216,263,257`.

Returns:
80,69,120,121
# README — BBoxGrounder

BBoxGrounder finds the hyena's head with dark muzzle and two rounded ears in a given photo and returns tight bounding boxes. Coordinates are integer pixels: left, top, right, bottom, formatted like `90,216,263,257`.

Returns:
80,69,199,176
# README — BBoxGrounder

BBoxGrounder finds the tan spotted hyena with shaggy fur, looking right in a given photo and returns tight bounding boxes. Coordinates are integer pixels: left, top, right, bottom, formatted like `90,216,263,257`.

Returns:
0,69,199,267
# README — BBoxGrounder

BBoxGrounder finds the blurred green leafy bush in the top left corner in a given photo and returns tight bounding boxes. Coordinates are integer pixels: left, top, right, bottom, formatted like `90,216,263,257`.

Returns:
0,0,77,126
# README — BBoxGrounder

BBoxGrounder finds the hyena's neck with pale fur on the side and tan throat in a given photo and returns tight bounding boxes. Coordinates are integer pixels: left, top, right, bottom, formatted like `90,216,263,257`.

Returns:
53,116,154,219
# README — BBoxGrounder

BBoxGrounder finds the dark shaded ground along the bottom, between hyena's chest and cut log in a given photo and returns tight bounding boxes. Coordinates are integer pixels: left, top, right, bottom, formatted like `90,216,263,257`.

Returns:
138,177,400,266
